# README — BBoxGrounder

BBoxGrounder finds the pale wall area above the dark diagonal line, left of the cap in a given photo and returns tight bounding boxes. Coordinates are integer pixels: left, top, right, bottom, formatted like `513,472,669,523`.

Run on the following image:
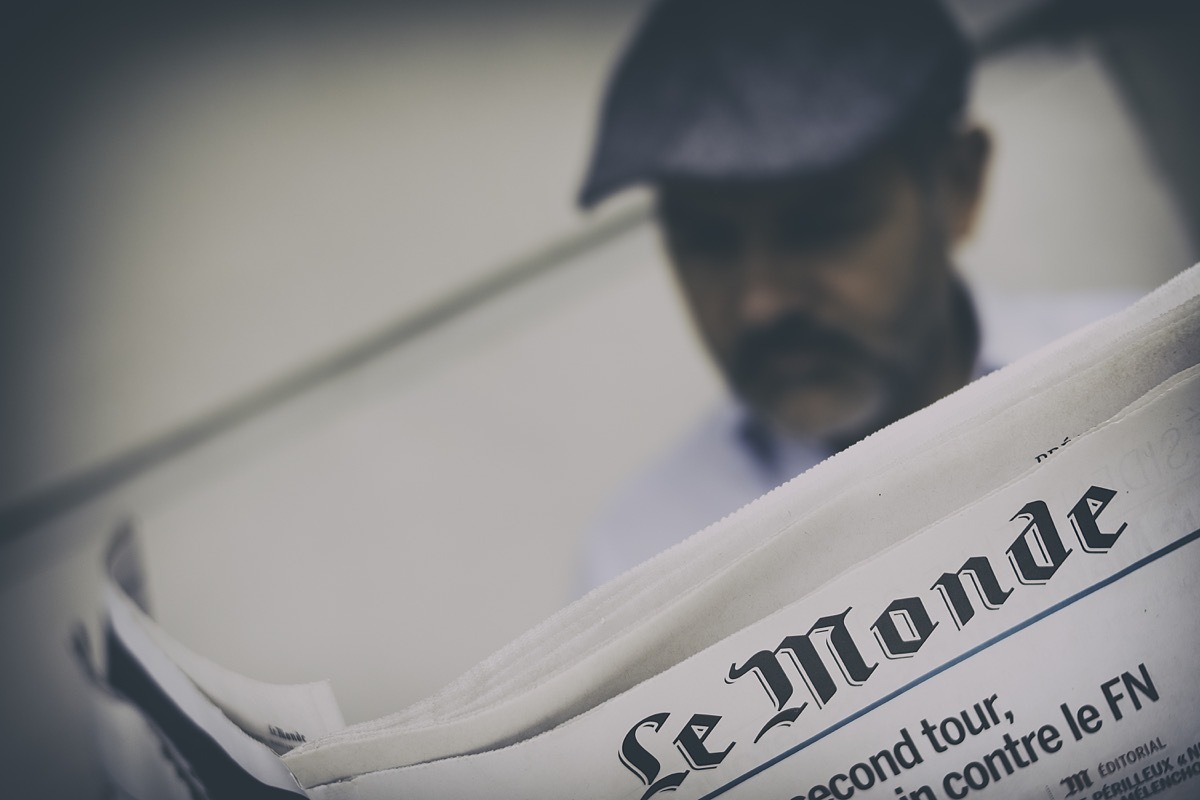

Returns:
0,2,657,503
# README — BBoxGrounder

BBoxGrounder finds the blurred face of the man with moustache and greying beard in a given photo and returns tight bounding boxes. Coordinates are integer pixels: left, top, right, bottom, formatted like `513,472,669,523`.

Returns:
659,156,965,444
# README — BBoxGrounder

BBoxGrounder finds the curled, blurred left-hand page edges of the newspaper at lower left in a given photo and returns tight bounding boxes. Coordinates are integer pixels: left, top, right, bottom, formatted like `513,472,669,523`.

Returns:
94,530,344,800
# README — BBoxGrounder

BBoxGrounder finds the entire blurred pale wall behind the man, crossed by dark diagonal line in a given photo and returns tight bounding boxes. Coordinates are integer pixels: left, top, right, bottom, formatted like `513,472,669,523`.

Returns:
0,0,1200,796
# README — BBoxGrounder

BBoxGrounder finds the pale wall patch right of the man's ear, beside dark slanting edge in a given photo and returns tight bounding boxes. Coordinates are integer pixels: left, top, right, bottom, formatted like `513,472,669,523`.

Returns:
961,42,1200,291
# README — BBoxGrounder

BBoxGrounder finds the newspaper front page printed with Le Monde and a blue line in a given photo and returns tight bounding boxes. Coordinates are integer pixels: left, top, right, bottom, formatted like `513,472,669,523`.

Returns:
310,368,1200,800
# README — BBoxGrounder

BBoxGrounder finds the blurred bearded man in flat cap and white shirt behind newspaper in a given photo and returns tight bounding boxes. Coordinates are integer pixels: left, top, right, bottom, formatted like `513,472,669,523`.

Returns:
581,0,989,587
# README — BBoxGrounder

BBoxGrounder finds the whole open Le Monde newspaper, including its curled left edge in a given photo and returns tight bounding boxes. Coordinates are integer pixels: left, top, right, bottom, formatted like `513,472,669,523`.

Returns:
88,266,1200,800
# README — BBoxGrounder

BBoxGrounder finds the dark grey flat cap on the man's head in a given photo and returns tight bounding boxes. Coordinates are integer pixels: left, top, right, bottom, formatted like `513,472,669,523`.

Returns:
580,0,972,206
